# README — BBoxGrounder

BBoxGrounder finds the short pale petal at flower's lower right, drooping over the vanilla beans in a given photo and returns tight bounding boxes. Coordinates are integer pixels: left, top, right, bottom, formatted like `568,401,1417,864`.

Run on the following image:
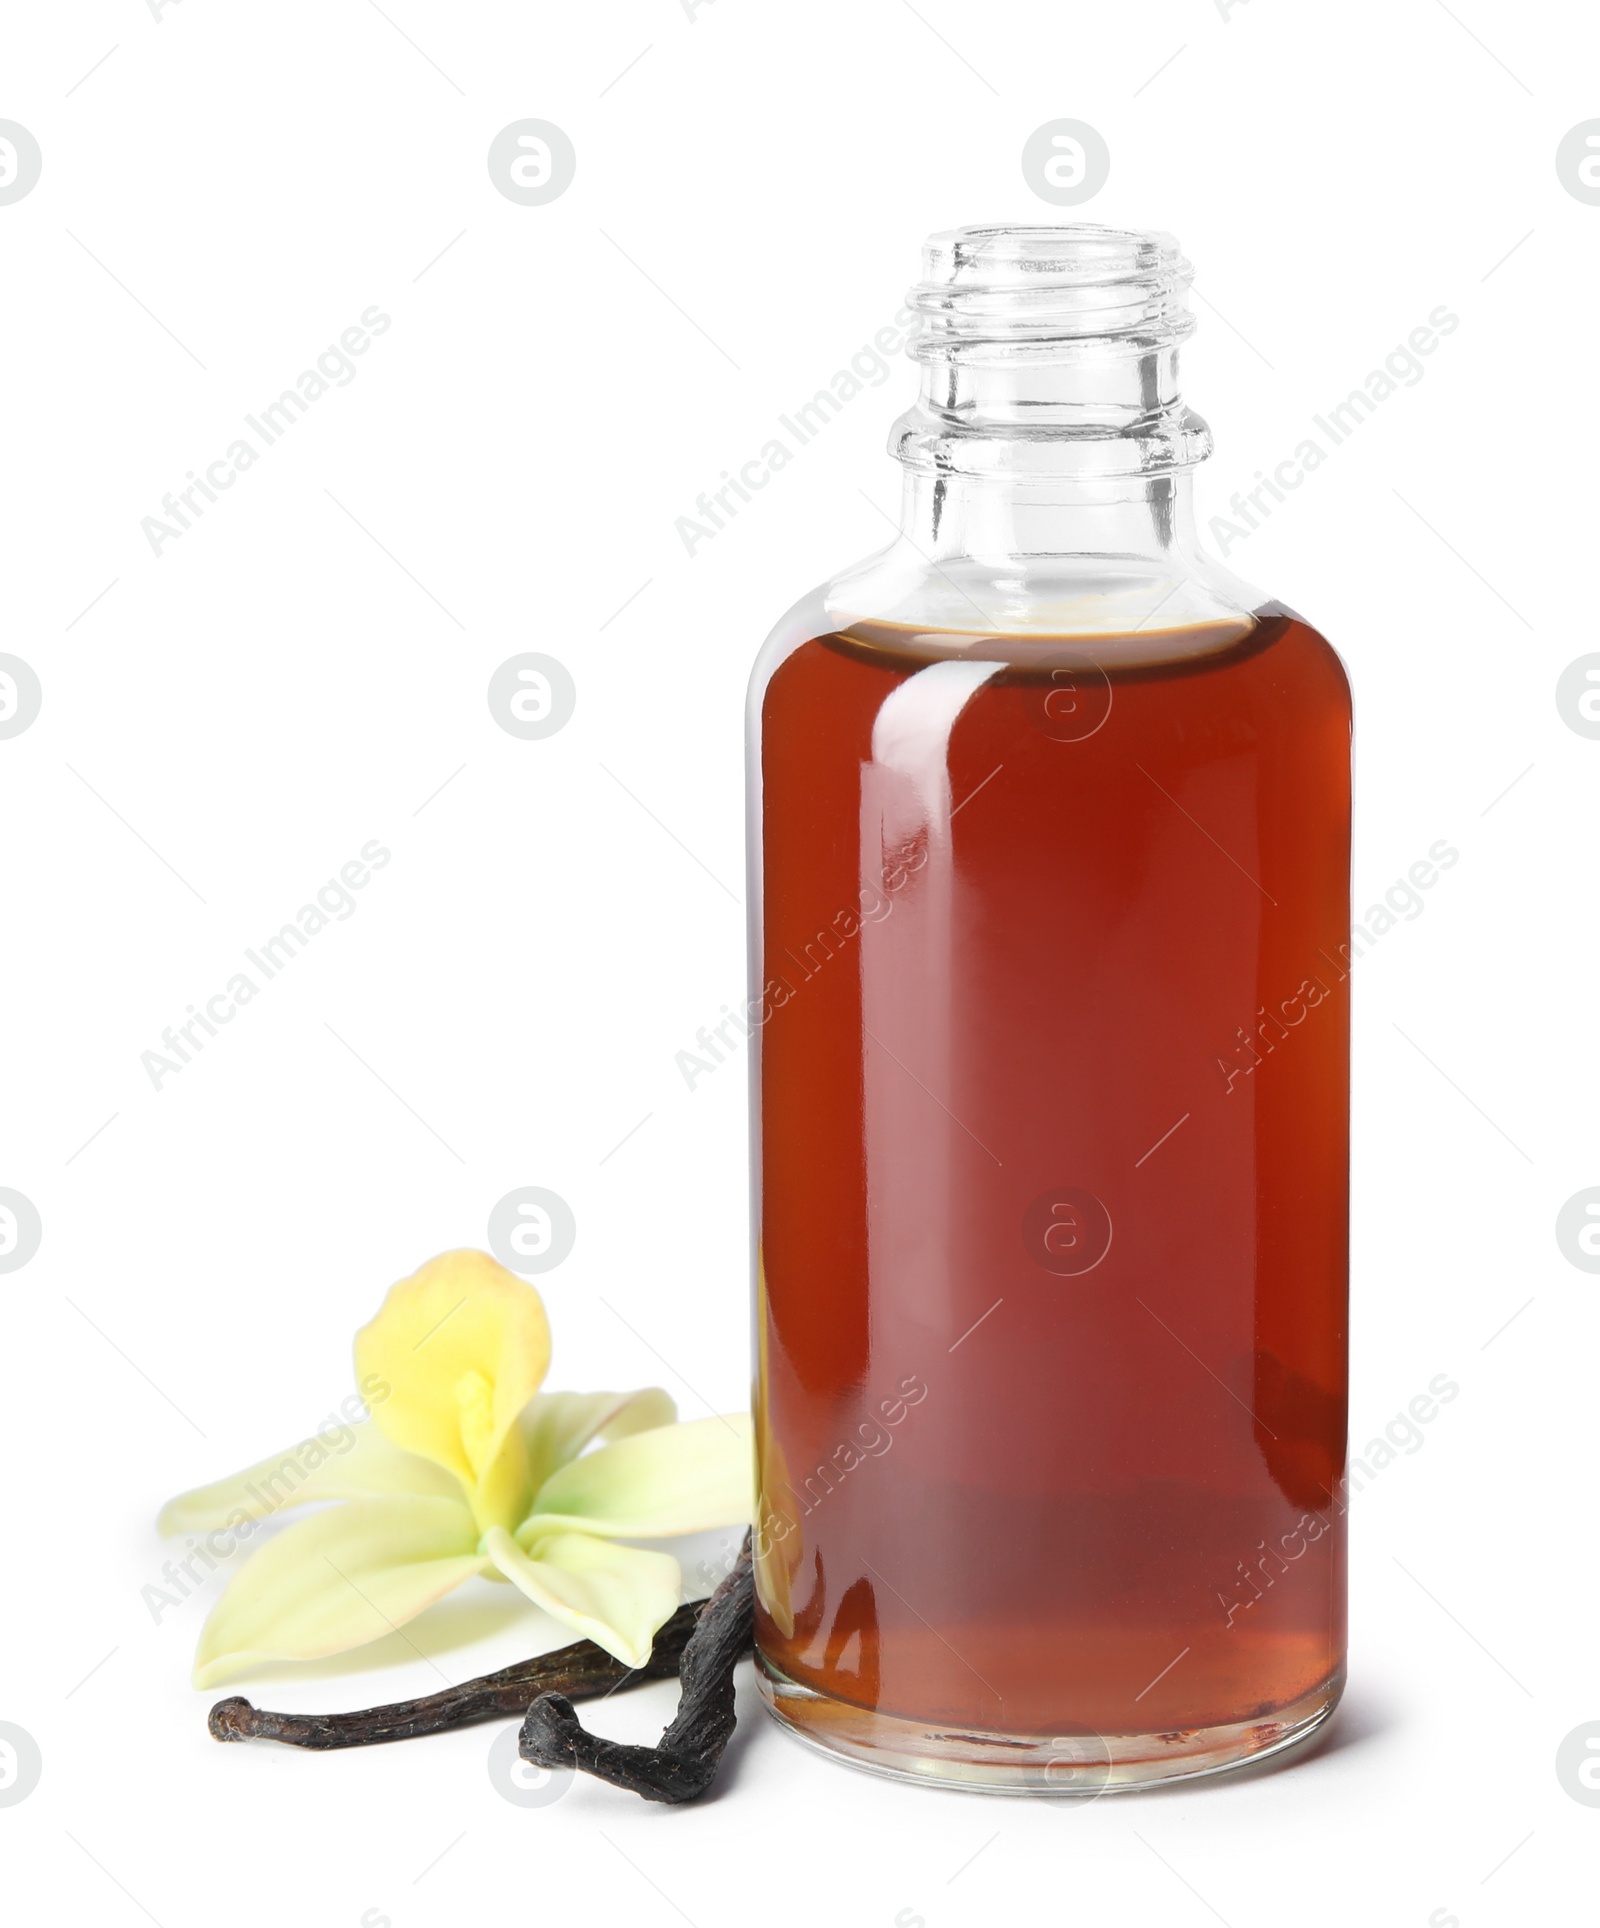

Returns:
484,1527,682,1668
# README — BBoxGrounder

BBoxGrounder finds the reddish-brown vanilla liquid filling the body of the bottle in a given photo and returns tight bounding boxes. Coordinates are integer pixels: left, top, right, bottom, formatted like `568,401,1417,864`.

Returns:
758,605,1349,1737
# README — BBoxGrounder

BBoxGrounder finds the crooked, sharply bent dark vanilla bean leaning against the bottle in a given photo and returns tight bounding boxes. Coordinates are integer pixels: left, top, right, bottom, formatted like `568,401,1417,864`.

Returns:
519,1533,756,1801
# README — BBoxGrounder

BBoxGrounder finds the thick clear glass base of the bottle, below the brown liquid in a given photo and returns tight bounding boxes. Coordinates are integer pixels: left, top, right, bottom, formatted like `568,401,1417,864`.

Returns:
756,1652,1344,1801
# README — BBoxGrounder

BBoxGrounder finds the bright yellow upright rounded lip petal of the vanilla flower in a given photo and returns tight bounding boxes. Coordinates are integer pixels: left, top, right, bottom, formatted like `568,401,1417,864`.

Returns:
355,1251,549,1525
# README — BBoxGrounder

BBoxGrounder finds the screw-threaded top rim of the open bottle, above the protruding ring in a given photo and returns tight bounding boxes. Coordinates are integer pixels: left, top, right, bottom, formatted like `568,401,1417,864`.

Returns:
906,222,1195,362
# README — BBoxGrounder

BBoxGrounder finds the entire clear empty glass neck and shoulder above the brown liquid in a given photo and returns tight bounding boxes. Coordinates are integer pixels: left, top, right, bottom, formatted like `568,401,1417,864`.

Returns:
813,226,1253,636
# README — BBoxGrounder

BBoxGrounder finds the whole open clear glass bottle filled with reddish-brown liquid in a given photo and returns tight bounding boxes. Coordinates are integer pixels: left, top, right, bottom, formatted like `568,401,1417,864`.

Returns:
746,226,1349,1793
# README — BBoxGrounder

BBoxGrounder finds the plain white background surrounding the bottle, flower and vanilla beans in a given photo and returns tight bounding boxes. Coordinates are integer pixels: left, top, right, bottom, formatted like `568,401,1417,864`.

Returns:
0,0,1600,1928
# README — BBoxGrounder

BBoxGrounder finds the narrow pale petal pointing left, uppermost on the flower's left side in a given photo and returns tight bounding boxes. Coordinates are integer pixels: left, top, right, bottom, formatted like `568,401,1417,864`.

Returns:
156,1421,461,1533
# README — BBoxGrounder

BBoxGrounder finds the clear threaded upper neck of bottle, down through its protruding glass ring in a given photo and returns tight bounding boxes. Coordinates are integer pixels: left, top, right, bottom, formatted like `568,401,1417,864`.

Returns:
889,224,1211,482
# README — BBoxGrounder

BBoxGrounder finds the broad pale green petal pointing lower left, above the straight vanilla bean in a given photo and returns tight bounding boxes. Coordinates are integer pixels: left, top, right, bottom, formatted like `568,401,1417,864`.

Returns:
195,1498,486,1687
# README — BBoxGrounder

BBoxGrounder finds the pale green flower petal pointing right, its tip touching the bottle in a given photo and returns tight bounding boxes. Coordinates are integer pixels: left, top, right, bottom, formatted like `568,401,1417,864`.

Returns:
517,1413,756,1546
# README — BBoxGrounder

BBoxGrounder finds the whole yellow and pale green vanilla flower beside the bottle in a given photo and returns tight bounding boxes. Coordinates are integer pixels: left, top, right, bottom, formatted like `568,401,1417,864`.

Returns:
160,1251,754,1687
